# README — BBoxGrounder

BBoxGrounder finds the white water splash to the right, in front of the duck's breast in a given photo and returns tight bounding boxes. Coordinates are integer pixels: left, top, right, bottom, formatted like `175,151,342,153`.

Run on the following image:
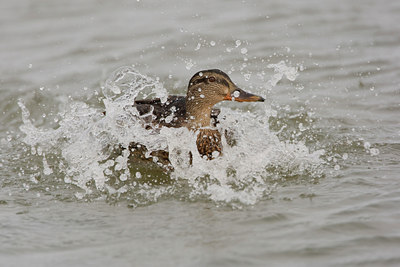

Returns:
164,107,324,204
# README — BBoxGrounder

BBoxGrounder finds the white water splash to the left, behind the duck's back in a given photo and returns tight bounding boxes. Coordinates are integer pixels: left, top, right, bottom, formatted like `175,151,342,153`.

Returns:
18,67,167,194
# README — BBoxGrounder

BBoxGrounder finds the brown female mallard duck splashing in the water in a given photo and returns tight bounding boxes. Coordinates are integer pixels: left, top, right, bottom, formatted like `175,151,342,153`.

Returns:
130,69,264,164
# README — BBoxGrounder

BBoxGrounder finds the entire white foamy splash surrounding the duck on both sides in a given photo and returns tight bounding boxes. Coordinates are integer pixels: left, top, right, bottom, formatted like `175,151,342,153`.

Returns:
18,62,325,205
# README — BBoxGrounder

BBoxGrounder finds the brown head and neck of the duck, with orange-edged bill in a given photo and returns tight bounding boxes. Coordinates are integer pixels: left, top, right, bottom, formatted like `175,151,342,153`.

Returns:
186,69,264,127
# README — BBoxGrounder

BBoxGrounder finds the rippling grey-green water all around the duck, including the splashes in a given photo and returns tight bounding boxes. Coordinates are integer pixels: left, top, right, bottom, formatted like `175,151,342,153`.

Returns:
0,0,400,266
